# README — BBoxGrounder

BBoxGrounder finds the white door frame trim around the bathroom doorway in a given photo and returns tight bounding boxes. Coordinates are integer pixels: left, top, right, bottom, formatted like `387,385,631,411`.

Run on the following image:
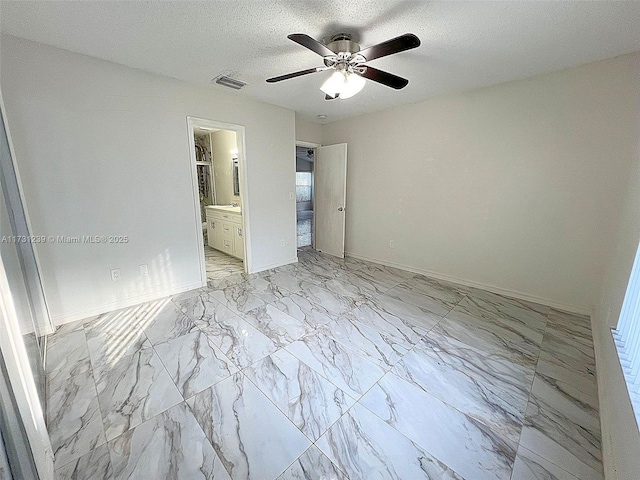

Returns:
187,116,253,280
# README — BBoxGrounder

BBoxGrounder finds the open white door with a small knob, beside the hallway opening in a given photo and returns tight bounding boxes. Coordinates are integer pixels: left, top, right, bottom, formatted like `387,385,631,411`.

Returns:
314,143,347,258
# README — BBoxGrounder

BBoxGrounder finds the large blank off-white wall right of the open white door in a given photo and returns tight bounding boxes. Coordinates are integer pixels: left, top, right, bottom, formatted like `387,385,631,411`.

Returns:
322,55,639,312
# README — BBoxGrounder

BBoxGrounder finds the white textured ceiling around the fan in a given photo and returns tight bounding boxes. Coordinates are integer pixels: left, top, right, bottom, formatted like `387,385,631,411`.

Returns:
0,0,640,123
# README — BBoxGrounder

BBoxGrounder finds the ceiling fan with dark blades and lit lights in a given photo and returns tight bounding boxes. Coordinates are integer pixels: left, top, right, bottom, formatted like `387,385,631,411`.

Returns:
267,33,420,100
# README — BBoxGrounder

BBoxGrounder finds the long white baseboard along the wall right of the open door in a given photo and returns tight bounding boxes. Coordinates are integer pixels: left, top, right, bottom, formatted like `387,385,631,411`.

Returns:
345,252,592,316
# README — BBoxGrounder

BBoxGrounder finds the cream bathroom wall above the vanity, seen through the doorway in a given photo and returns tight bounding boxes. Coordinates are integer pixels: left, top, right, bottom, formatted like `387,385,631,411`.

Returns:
211,130,240,205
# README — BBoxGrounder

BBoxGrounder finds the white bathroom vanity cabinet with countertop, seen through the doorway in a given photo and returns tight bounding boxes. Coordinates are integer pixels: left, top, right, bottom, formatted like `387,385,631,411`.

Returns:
206,205,244,260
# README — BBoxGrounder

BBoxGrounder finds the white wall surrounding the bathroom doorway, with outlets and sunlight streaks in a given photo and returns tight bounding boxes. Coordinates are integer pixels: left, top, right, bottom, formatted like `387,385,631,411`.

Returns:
0,36,296,324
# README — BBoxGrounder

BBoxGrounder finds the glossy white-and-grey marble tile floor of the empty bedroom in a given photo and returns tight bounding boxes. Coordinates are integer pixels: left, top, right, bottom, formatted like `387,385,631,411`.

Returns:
46,248,603,480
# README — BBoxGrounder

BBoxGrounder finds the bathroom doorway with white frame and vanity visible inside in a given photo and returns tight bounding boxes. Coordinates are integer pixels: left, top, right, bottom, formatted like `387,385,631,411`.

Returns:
187,117,249,284
